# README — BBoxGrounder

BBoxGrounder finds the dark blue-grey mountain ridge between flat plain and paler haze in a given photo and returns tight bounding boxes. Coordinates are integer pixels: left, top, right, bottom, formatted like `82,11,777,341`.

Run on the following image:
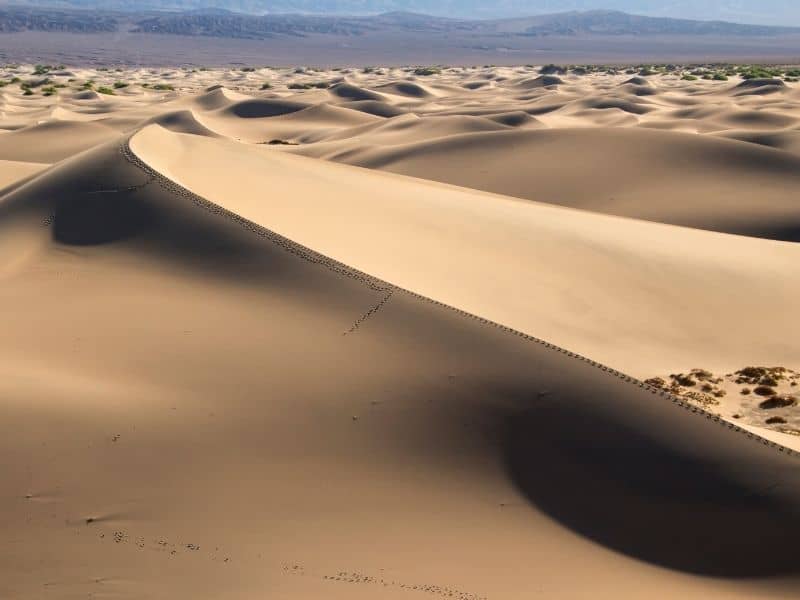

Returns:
0,7,800,39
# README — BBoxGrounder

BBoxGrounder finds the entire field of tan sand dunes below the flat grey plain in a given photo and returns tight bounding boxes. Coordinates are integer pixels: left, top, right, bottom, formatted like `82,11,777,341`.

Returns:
0,66,800,600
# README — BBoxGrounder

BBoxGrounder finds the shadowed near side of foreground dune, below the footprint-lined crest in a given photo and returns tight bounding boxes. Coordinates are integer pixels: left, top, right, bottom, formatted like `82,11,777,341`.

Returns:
0,132,800,599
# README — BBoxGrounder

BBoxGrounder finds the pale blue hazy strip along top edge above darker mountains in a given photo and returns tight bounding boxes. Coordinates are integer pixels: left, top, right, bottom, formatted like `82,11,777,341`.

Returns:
8,0,800,26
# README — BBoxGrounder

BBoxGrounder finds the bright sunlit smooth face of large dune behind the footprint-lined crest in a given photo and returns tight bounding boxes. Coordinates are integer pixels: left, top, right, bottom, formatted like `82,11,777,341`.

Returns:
130,127,800,376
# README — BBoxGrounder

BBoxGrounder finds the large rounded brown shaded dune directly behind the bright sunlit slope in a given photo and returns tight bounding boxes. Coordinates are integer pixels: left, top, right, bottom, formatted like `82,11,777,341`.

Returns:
295,127,800,241
